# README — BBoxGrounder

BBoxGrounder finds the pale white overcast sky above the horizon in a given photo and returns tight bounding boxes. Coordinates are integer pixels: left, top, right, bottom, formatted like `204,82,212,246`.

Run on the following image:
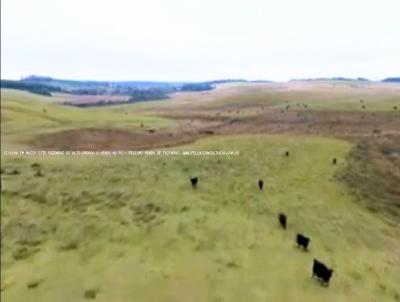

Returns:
1,0,400,81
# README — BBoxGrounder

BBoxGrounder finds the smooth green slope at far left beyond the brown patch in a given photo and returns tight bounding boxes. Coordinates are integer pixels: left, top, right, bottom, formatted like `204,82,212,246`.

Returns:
1,89,170,148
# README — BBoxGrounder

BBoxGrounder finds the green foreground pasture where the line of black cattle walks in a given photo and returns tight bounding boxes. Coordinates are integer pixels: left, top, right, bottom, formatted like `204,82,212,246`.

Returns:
1,136,400,301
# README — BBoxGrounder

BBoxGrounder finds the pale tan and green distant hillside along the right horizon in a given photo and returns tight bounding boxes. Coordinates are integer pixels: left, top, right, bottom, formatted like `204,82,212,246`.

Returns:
138,82,400,113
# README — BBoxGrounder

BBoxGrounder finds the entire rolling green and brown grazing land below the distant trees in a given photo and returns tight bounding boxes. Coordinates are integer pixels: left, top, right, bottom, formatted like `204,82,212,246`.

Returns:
1,82,400,302
